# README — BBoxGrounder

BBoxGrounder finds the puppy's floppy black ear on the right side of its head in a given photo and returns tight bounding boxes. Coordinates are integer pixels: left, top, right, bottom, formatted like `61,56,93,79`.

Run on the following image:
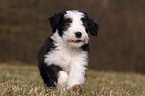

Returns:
84,13,99,36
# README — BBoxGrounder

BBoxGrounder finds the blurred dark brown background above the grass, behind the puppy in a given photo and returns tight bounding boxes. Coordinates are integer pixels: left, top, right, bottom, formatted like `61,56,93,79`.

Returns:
0,0,145,73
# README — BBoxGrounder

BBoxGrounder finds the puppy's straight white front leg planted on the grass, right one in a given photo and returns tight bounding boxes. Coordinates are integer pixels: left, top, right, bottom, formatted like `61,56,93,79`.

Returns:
67,64,86,89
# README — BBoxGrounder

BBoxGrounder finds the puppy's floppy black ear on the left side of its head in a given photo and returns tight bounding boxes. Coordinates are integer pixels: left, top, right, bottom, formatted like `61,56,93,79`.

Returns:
48,12,63,33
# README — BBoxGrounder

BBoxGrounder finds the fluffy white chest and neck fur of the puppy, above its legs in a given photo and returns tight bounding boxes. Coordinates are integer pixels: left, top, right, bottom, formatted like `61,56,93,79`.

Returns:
44,33,88,72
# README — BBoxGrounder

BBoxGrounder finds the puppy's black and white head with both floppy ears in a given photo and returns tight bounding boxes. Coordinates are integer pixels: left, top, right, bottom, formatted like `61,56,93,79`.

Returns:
49,10,99,48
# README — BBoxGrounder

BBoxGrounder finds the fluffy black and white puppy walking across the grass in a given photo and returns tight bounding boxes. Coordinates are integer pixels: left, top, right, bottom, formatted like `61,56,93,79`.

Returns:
38,10,99,89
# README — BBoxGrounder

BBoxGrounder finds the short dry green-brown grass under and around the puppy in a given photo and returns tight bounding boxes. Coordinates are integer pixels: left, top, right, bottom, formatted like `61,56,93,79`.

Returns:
0,64,145,96
